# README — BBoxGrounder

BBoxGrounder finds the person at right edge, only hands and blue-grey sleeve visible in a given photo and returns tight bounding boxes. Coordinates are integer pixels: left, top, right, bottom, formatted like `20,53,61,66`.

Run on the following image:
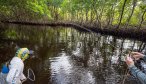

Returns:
126,52,146,84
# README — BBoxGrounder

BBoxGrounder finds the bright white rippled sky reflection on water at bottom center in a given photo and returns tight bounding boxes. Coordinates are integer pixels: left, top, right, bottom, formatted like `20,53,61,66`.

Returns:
50,53,95,84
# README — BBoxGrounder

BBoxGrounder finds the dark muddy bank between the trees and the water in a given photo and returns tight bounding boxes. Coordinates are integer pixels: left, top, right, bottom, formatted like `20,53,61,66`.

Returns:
1,21,146,41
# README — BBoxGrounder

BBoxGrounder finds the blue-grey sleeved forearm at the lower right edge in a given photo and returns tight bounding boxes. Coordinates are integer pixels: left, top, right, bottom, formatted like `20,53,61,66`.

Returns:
129,66,146,84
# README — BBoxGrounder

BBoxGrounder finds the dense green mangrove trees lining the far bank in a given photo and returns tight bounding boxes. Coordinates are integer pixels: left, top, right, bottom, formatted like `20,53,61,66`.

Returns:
0,0,146,29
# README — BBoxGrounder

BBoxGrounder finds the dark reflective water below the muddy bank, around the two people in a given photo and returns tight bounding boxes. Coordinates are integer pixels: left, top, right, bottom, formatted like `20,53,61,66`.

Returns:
0,25,144,84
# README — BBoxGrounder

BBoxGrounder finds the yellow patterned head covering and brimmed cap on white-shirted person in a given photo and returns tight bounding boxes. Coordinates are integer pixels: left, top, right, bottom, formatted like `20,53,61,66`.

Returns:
15,48,34,61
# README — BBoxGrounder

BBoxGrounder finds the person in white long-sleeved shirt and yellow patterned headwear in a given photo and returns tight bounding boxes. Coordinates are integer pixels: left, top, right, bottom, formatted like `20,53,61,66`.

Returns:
6,48,33,84
